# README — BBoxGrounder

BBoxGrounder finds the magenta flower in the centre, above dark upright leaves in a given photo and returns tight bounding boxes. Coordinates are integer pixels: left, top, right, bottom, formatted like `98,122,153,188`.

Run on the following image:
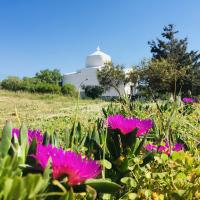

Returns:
105,114,153,136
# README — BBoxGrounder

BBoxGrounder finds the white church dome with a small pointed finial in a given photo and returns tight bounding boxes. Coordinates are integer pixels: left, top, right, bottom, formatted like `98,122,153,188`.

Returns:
86,47,111,68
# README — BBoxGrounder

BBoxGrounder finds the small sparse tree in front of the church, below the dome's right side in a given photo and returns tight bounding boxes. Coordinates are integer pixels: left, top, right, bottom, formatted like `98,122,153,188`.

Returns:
97,62,126,96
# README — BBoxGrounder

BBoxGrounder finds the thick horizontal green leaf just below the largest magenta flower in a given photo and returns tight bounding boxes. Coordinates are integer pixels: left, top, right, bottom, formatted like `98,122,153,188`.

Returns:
85,179,121,193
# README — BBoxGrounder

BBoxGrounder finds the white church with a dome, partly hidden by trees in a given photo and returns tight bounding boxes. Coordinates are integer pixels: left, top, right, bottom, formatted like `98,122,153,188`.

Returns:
63,47,136,98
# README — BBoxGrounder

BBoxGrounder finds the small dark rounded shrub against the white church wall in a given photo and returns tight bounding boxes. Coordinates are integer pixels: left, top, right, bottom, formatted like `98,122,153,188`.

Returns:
83,85,104,99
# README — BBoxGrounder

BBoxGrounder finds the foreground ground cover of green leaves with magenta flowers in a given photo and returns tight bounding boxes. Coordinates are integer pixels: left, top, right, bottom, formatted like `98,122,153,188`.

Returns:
0,91,200,199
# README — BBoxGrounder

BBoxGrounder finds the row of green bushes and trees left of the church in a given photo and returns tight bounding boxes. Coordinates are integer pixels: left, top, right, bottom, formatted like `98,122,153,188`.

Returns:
1,69,77,96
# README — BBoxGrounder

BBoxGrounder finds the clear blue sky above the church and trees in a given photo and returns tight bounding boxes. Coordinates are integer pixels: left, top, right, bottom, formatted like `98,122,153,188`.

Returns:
0,0,200,78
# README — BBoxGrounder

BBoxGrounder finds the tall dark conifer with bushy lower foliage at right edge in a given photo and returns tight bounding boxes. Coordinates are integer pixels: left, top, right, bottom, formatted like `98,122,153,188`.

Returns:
145,24,200,93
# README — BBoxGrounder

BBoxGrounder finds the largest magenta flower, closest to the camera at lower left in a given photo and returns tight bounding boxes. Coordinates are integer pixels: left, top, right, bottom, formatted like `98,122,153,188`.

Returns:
35,144,101,186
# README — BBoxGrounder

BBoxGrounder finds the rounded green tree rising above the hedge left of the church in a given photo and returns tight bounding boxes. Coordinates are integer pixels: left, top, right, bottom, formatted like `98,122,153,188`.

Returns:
35,69,62,85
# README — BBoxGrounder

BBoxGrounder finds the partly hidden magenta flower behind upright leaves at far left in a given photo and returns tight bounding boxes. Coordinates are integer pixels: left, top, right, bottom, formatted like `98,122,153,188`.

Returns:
12,128,43,144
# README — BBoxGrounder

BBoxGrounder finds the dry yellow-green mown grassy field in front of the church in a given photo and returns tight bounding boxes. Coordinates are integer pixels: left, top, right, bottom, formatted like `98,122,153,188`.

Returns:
0,90,107,131
